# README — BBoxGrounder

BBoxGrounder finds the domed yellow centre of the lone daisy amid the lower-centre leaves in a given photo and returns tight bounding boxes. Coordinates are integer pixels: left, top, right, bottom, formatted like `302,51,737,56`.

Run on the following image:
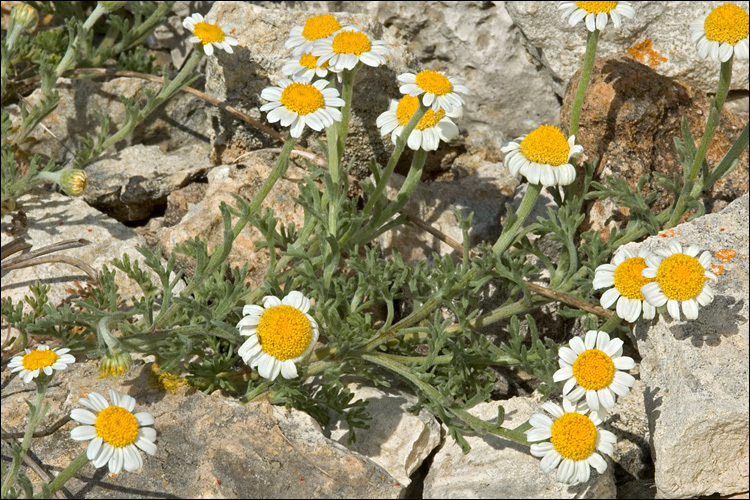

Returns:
255,305,312,361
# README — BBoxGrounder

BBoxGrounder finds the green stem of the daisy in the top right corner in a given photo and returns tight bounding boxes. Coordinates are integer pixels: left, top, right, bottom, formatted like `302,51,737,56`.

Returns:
666,55,734,228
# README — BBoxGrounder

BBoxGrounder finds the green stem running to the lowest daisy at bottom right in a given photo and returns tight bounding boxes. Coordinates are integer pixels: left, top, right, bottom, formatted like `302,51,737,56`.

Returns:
362,353,529,446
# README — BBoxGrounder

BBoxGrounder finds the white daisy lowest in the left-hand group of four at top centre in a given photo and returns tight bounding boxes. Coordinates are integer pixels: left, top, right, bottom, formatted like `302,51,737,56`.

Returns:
260,78,344,137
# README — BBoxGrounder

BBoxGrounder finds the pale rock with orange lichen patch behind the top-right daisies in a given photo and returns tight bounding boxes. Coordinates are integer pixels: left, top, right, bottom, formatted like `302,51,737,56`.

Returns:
505,1,748,96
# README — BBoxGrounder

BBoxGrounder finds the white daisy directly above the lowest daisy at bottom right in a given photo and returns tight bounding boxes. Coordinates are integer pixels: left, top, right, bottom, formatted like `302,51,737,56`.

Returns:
552,330,635,412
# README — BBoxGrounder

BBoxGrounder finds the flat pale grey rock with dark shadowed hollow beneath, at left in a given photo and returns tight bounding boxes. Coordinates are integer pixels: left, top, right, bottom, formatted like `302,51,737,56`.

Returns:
83,144,209,222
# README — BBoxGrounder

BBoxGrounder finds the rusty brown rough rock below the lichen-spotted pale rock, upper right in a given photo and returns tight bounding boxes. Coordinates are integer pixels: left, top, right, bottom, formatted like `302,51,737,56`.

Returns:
561,56,749,238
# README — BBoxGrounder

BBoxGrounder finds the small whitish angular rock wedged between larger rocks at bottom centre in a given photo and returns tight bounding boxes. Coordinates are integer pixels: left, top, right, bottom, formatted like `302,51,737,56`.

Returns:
329,382,440,487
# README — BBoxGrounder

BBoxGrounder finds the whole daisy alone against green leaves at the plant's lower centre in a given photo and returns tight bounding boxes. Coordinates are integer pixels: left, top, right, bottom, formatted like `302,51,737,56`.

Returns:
237,291,319,380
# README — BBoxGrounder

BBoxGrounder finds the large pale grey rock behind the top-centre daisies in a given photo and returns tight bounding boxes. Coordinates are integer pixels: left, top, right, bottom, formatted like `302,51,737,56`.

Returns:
207,2,559,177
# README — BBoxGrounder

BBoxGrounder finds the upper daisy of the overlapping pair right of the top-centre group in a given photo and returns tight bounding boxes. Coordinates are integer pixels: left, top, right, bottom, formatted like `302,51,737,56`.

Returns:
398,69,469,113
